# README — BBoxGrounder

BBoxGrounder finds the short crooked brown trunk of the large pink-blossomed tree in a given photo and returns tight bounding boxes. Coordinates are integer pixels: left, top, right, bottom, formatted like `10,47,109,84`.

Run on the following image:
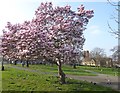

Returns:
57,61,65,84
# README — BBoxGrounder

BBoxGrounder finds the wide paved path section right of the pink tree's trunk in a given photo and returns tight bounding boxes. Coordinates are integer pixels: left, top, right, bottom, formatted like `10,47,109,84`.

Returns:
67,74,120,91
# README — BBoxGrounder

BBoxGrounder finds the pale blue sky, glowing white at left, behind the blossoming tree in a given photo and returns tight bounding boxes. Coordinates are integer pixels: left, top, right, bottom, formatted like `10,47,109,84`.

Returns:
0,0,118,56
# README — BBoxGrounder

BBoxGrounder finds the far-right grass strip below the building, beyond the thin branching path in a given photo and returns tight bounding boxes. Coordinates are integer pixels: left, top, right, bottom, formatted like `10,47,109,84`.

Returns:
78,66,120,76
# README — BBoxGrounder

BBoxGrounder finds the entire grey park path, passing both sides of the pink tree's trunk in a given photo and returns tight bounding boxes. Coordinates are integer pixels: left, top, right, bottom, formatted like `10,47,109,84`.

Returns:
8,66,120,91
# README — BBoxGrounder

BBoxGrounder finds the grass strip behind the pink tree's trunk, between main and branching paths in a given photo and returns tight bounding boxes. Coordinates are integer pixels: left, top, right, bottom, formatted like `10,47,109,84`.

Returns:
13,65,96,76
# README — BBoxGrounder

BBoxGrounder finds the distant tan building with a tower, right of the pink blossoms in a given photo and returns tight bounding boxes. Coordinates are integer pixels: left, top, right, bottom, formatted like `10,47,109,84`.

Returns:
81,51,113,67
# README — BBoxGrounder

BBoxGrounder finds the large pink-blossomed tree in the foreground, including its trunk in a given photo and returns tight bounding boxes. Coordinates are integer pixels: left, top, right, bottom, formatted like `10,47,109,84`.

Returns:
2,2,93,83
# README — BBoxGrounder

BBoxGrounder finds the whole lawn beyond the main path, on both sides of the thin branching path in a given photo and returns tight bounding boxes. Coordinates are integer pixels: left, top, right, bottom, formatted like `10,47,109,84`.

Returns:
12,65,120,76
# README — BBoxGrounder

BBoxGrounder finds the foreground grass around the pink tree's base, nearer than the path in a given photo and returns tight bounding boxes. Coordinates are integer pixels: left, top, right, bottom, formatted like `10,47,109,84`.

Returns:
2,66,117,93
